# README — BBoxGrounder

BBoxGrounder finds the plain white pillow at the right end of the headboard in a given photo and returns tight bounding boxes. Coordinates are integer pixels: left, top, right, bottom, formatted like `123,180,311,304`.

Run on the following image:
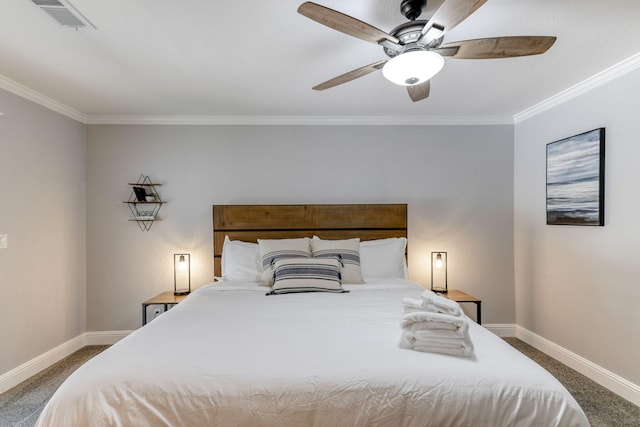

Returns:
360,237,407,281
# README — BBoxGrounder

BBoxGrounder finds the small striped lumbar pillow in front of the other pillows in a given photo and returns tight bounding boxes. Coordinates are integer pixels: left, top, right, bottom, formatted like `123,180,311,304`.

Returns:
267,258,345,295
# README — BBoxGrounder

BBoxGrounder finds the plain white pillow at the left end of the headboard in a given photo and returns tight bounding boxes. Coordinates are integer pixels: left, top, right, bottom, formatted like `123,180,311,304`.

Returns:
222,236,262,282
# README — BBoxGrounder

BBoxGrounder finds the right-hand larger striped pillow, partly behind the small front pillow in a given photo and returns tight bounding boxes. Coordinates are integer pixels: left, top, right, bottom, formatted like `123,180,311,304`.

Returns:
311,236,363,283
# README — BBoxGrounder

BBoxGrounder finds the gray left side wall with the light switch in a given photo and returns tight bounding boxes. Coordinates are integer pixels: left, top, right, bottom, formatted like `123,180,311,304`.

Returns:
0,90,86,374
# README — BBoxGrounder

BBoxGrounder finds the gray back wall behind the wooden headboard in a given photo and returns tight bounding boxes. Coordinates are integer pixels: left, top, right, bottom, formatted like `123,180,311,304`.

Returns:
87,125,515,331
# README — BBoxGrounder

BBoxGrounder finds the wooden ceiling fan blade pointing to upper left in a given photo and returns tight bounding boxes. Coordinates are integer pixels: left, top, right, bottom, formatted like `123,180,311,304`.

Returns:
298,1,400,44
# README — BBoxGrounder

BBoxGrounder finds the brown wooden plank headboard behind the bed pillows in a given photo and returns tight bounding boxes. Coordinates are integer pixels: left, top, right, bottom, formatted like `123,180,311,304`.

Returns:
213,204,407,277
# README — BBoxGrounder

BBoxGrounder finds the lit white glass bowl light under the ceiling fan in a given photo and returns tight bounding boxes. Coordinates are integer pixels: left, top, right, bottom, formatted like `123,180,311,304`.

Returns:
382,50,444,86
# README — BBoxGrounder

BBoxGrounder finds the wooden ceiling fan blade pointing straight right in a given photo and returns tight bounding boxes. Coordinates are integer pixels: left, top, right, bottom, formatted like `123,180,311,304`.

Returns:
434,36,556,59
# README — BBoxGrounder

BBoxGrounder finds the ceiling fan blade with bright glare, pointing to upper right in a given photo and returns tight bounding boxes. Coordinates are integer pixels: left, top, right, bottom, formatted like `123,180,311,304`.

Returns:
418,0,488,46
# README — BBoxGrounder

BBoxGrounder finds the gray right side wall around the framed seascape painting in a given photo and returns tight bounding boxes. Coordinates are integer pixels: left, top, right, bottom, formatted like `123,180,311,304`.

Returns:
514,70,640,384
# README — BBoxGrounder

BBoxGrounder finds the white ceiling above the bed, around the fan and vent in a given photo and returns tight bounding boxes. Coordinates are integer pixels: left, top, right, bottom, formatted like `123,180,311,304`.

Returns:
0,0,640,122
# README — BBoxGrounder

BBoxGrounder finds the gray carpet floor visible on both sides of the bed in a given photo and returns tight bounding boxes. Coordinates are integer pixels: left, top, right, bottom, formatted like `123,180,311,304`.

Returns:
0,338,640,427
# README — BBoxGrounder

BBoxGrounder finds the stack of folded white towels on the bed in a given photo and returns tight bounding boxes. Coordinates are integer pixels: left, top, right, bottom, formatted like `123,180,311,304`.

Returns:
400,290,473,356
